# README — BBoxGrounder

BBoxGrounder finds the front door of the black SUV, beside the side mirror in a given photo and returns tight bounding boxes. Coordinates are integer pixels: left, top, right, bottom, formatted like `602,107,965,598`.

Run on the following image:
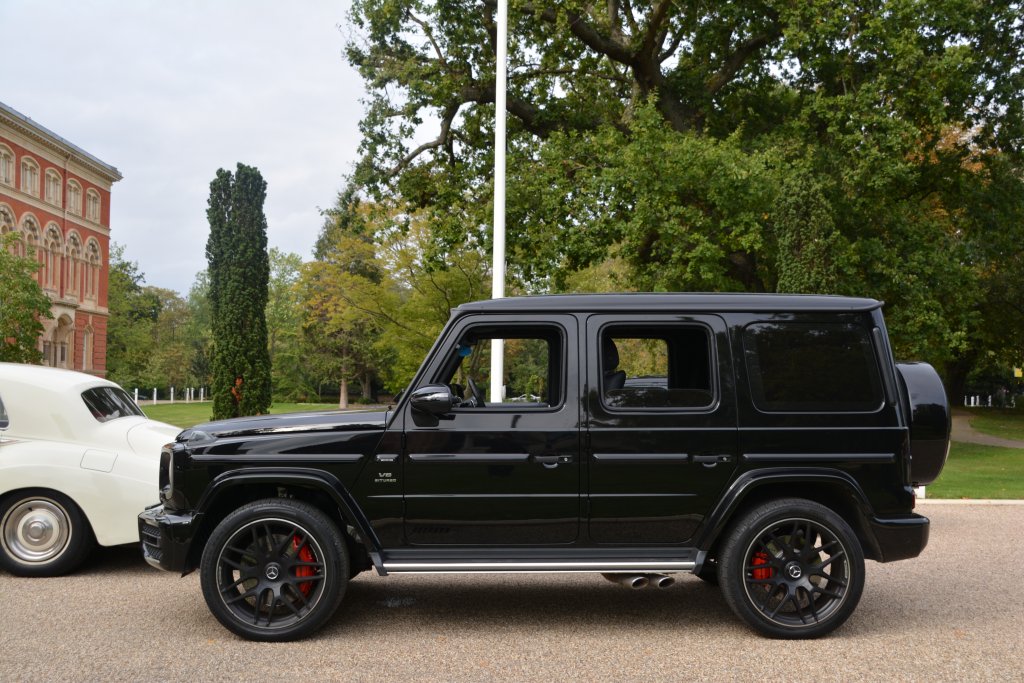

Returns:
402,315,580,546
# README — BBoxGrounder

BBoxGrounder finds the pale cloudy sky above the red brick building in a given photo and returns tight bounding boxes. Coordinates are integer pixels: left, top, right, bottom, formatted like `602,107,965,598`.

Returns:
0,0,364,295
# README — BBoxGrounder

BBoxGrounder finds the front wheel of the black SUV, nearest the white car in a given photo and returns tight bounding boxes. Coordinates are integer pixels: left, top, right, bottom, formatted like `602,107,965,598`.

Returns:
200,499,348,641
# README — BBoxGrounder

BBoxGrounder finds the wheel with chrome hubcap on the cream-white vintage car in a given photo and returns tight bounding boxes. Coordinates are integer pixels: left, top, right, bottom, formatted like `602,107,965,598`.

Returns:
0,488,96,577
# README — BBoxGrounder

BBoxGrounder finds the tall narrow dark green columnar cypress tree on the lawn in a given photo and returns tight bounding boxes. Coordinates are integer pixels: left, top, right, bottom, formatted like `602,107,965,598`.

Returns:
206,164,270,420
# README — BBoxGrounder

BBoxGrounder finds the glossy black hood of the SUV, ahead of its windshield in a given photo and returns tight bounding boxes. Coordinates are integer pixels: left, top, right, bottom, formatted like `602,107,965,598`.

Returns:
178,411,388,441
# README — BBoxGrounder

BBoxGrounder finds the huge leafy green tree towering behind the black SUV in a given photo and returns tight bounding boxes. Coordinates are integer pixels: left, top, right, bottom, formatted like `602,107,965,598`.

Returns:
347,0,1024,385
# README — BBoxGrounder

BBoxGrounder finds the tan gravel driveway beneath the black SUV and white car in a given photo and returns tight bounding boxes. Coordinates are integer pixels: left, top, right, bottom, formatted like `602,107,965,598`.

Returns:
0,502,1024,683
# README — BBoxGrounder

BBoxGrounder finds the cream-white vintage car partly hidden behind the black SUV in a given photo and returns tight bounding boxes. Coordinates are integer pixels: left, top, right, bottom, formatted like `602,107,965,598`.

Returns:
0,362,180,577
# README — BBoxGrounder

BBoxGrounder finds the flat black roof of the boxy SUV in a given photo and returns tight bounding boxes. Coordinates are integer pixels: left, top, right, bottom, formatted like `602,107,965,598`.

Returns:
455,292,883,313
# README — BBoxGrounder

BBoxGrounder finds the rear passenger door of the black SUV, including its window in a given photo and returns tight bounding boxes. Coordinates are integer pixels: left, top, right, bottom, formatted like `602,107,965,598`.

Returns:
586,315,737,545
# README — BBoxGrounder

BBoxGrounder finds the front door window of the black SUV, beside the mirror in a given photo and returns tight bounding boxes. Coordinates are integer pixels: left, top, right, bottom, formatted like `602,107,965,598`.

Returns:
435,326,564,408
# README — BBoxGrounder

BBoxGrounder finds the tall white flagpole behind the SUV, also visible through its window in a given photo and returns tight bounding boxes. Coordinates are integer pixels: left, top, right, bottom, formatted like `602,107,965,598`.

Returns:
490,0,508,402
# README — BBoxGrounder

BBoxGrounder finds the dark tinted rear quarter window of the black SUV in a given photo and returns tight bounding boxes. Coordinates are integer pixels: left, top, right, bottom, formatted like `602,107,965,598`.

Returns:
743,323,883,413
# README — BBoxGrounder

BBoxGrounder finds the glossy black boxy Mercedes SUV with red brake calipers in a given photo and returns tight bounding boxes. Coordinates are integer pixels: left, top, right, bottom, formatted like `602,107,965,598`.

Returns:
139,294,949,640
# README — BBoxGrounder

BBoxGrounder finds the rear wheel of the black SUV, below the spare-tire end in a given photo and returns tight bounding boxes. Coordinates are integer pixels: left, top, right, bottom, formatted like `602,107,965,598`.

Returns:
719,499,864,638
